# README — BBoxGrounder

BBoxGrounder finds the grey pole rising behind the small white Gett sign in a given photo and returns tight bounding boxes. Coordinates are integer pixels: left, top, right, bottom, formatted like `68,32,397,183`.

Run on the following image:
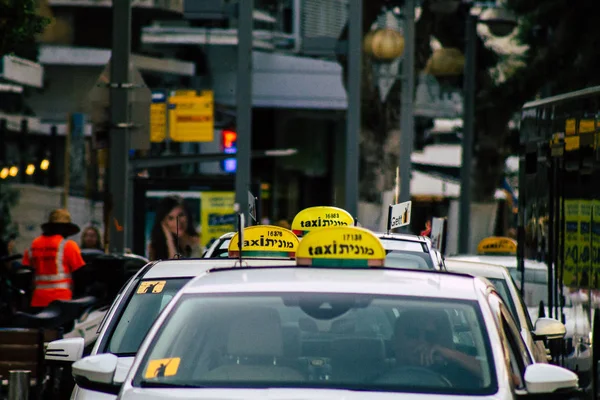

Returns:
399,0,415,232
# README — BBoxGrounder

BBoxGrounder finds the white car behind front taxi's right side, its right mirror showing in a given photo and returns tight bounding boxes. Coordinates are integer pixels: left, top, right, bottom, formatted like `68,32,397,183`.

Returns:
446,260,566,363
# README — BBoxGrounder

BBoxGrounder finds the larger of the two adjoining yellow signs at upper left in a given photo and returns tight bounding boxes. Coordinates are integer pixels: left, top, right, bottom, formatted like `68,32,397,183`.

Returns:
168,91,215,142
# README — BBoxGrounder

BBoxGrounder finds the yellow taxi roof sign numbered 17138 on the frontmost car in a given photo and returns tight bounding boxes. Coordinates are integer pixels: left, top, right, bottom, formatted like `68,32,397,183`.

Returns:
296,226,385,268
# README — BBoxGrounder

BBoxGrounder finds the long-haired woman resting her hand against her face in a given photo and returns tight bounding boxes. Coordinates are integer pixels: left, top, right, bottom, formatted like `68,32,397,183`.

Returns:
148,196,202,260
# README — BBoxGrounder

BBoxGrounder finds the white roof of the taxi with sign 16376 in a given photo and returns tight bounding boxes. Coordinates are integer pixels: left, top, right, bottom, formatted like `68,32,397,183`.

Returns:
142,258,296,279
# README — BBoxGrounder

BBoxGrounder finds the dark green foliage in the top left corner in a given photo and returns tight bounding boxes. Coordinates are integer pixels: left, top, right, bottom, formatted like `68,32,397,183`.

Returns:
0,0,50,58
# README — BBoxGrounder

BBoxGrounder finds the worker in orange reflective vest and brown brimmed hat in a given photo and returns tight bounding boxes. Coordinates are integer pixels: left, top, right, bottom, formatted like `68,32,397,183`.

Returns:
23,209,85,310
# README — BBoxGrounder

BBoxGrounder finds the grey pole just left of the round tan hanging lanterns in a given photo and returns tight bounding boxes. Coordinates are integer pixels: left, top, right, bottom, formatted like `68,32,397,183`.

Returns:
344,0,363,218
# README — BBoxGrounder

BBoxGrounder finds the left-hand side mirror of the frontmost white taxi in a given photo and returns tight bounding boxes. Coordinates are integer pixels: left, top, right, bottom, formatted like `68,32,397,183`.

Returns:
72,353,122,395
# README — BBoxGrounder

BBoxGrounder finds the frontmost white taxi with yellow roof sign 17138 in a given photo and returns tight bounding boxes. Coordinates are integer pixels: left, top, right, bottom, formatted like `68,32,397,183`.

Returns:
73,227,578,400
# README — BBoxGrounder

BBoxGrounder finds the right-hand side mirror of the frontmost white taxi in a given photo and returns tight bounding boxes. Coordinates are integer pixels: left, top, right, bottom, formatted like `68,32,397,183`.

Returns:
525,364,579,394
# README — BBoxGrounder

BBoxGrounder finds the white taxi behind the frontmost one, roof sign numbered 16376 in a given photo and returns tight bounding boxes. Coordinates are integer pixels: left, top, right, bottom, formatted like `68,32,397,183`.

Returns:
46,226,298,400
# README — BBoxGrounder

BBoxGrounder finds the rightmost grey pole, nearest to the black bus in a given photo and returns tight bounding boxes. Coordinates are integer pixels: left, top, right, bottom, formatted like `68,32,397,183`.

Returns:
458,12,478,254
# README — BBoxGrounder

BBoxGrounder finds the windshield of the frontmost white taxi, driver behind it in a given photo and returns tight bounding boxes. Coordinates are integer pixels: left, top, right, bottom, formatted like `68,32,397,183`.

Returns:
133,293,497,394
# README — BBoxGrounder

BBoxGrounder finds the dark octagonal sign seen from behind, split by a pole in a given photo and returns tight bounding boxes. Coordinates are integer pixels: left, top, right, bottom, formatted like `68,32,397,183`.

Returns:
84,60,152,150
